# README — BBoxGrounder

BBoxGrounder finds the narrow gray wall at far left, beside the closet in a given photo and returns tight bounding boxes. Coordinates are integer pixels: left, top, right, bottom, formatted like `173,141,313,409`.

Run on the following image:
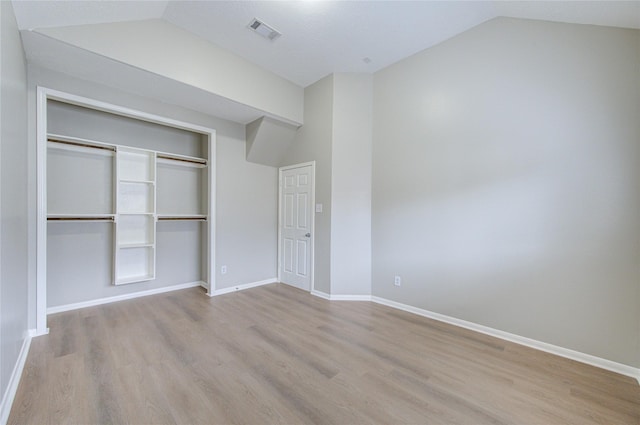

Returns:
0,1,27,408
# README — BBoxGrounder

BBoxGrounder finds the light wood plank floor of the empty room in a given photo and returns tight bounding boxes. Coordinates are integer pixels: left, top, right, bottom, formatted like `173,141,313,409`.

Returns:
9,284,640,425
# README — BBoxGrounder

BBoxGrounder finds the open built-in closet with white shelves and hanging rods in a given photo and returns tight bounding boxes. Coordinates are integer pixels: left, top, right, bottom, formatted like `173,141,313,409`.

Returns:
46,96,214,309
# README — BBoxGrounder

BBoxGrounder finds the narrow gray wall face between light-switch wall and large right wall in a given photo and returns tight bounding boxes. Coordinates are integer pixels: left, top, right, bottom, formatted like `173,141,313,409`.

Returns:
332,73,373,295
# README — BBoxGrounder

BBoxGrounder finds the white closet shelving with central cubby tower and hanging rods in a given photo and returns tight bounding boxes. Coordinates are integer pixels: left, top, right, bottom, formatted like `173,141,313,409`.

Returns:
47,134,208,285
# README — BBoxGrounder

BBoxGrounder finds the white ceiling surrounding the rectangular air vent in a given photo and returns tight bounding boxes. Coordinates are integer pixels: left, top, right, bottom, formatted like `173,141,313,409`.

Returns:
13,0,640,87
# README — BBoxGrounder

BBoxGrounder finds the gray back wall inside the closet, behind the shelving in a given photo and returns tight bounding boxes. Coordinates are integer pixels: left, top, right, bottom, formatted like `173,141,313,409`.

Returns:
47,100,209,308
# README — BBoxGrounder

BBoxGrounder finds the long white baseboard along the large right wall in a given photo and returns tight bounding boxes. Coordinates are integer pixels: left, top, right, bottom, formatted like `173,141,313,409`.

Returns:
371,297,640,384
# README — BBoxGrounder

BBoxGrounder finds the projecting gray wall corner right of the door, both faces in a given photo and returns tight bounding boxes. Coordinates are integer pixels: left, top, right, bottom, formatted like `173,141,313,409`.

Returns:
282,73,373,295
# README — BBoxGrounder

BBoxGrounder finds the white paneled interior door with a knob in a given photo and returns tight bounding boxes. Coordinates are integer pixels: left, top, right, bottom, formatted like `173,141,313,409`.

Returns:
279,164,314,291
